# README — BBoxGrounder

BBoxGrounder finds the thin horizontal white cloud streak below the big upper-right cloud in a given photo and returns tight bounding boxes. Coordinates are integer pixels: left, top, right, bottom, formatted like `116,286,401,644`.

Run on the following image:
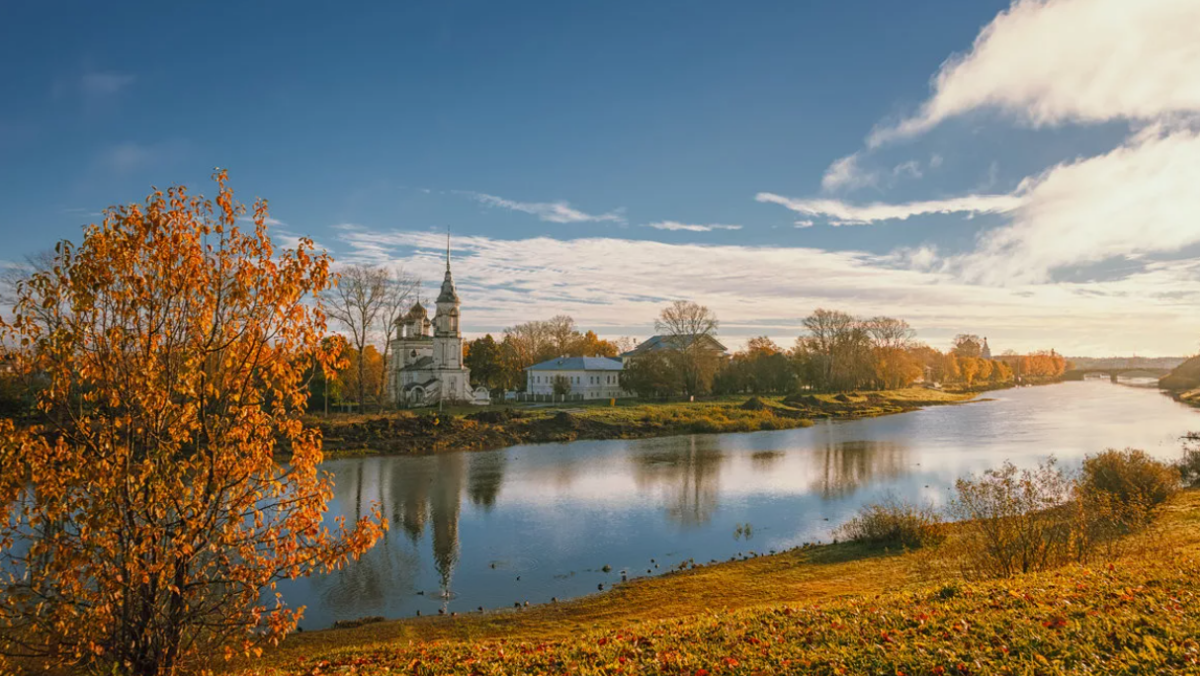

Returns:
755,192,1024,226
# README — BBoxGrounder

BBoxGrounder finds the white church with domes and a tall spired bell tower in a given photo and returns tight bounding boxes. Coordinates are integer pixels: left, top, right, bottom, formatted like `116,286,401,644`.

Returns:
388,246,491,407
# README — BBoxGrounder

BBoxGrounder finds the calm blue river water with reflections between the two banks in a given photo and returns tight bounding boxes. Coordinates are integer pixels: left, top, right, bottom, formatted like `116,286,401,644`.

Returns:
281,381,1200,629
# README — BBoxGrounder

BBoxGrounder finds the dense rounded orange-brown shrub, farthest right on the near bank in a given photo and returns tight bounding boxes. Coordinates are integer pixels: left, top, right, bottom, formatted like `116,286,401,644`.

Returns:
1080,449,1180,512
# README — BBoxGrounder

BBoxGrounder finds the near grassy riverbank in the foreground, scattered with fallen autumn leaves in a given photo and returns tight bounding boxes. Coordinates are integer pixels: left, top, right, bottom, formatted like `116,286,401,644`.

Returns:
233,490,1200,676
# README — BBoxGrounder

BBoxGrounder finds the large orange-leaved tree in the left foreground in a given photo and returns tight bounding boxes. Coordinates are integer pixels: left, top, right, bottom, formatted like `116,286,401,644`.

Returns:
0,172,386,675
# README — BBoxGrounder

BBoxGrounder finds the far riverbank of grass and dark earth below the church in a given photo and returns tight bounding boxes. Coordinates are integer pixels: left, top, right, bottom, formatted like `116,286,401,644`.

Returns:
311,388,978,457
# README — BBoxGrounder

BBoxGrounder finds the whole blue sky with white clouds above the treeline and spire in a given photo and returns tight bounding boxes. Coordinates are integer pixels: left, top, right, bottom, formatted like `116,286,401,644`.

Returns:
0,0,1200,357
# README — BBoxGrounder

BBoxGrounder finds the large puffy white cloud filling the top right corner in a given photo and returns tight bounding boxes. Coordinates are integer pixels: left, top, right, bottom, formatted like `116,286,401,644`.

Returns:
868,0,1200,148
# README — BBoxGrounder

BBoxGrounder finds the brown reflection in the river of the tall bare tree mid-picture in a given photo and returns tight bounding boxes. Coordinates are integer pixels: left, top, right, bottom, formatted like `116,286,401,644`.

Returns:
631,436,725,527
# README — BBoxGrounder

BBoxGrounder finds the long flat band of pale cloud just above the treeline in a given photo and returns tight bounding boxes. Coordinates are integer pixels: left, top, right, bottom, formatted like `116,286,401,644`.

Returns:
335,228,1200,354
